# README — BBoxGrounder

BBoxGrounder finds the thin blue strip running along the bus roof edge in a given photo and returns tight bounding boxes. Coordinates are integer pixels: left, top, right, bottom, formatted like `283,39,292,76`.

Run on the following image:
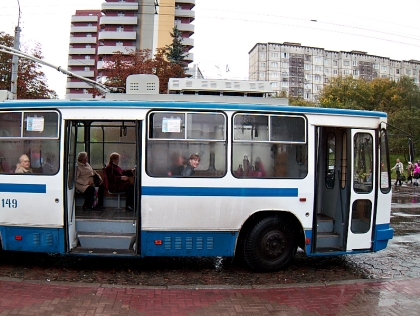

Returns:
2,98,387,118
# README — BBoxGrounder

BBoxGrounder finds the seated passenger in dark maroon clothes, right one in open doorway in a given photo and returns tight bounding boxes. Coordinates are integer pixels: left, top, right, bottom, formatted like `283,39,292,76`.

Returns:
105,152,134,211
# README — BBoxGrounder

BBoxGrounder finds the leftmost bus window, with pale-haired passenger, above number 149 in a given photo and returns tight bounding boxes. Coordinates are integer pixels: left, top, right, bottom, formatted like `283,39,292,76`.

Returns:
0,111,60,175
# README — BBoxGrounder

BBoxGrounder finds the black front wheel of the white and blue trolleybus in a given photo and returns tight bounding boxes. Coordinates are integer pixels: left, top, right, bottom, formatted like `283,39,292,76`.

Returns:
243,216,296,272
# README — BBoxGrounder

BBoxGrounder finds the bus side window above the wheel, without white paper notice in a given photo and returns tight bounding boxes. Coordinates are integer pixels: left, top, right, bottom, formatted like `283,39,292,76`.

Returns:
232,113,308,178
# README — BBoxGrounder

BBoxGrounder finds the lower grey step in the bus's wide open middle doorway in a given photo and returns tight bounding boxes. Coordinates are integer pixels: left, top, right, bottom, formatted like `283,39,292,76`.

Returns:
77,232,135,249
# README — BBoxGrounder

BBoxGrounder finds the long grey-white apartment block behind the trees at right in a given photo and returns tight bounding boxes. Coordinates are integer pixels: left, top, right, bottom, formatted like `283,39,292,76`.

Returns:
249,42,420,102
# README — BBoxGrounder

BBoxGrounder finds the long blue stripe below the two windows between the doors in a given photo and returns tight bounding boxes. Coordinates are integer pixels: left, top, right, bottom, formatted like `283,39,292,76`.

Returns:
142,186,298,197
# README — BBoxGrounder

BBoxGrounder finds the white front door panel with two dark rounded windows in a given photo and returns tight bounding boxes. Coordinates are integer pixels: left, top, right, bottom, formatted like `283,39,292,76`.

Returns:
346,129,378,251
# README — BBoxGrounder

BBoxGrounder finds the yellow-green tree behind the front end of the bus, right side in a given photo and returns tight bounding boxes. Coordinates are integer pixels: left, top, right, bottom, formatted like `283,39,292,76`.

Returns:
319,77,420,156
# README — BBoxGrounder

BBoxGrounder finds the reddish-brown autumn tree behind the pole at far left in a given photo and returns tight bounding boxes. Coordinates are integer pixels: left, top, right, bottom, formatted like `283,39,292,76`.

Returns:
0,32,58,99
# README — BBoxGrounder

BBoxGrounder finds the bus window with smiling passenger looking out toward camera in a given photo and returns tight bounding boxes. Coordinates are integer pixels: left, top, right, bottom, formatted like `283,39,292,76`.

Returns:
146,112,226,177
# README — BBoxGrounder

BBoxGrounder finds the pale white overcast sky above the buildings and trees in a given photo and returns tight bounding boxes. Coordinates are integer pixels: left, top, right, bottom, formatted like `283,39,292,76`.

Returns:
0,0,420,98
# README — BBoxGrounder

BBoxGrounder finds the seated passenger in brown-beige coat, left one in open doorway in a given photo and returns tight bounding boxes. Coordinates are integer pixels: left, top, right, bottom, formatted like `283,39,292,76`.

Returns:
76,151,103,211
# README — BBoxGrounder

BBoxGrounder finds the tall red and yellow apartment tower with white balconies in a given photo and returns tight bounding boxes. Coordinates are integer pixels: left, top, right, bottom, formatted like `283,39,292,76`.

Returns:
66,0,195,99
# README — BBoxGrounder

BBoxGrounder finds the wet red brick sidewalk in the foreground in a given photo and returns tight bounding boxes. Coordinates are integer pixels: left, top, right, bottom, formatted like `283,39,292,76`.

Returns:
0,278,420,316
